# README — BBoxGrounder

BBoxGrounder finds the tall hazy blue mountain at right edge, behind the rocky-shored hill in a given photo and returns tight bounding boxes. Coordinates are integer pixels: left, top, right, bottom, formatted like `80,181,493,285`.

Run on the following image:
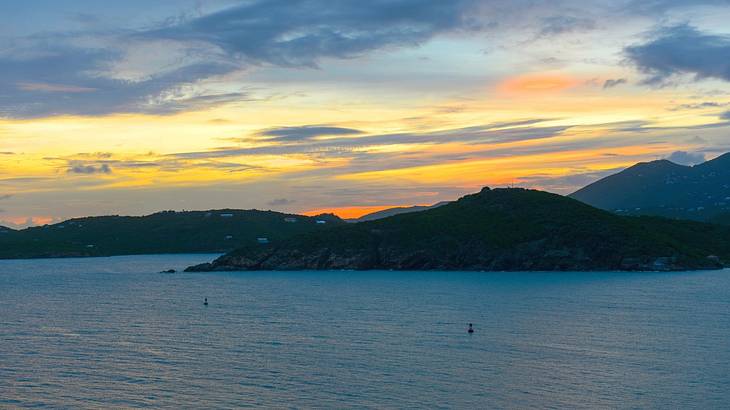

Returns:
570,153,730,220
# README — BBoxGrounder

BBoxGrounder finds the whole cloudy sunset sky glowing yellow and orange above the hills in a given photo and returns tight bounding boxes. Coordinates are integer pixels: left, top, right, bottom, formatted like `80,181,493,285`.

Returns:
0,0,730,227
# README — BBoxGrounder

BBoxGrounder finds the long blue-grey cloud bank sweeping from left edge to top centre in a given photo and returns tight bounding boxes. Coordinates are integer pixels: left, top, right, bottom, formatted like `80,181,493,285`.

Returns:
0,0,479,118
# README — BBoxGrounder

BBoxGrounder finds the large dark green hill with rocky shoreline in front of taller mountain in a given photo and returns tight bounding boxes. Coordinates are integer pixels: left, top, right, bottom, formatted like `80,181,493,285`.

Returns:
189,188,730,271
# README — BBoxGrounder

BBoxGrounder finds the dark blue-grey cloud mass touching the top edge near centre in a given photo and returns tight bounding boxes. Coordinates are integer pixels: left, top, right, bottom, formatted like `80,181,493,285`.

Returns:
144,0,477,67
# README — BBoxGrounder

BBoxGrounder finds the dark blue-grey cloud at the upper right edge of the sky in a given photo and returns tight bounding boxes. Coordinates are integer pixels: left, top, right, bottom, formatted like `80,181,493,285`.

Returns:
624,24,730,85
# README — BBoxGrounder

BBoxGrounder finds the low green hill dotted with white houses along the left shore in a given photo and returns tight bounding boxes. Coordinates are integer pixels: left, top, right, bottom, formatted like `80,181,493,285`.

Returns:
0,209,345,259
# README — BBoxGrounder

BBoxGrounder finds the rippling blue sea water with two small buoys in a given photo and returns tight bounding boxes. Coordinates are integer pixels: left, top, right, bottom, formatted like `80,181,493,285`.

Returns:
0,255,730,409
